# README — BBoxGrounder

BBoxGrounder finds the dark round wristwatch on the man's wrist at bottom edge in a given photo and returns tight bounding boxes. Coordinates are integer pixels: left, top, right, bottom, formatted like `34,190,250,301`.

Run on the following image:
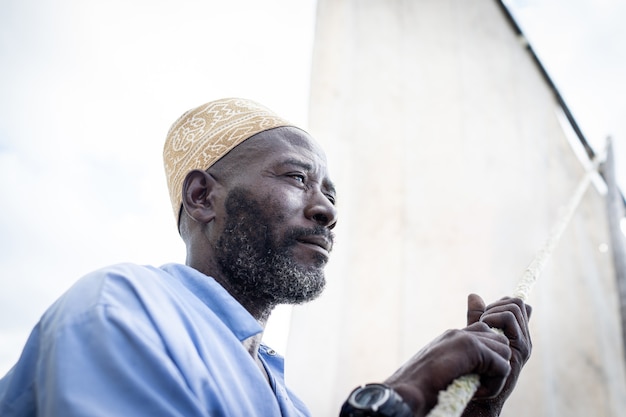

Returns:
339,384,413,417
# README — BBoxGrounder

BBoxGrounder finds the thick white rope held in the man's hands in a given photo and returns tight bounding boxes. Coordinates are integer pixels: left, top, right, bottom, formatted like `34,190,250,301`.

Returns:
426,155,600,417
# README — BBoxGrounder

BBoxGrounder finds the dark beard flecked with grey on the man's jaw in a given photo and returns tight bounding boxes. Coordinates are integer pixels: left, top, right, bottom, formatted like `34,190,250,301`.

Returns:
215,188,329,310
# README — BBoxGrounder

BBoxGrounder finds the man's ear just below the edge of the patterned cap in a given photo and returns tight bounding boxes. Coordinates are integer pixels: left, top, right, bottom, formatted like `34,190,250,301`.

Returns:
183,169,219,223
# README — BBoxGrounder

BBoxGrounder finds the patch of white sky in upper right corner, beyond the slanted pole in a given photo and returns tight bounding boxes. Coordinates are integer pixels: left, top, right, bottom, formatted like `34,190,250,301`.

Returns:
506,0,626,165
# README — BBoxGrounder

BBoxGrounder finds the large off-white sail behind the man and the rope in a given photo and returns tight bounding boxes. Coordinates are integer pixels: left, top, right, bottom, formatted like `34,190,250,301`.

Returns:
287,0,626,417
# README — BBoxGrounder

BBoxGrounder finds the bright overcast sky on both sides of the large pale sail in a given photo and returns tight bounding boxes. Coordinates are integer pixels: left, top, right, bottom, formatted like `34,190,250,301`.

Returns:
0,0,626,375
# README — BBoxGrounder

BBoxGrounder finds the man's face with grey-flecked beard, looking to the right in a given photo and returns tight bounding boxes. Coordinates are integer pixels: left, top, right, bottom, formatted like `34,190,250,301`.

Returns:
210,129,336,306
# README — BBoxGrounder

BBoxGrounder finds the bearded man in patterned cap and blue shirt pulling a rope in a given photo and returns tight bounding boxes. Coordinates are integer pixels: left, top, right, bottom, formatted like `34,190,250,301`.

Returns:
0,99,531,417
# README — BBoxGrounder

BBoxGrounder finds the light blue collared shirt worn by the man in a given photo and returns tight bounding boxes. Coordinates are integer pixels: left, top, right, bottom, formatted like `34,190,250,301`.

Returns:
0,264,309,417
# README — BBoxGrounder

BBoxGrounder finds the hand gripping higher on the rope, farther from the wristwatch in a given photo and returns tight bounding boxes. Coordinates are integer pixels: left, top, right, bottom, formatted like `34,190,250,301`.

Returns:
463,294,532,417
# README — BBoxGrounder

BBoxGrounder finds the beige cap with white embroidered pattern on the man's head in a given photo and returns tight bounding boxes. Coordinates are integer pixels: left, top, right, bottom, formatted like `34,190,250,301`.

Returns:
163,98,293,222
